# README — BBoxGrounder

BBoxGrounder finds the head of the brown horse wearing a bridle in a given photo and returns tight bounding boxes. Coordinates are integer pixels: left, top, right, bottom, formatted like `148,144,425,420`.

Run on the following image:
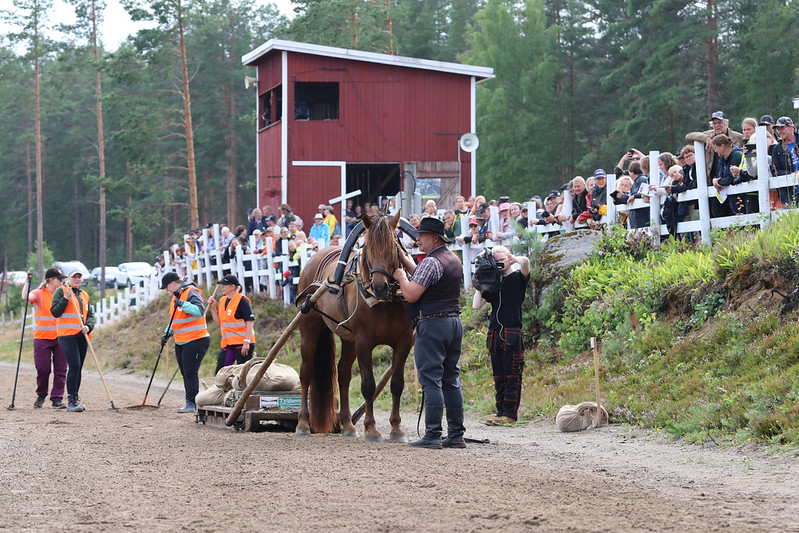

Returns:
362,211,402,300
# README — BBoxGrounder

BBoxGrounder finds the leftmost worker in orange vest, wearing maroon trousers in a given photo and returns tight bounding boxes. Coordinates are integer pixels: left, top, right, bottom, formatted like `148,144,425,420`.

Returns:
22,268,67,409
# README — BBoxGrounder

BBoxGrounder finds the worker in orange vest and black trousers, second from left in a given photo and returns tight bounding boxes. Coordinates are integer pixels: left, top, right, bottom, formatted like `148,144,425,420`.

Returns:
50,270,94,413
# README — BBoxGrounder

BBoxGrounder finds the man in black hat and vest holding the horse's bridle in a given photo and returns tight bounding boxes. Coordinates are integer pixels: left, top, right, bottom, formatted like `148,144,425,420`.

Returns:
394,217,466,448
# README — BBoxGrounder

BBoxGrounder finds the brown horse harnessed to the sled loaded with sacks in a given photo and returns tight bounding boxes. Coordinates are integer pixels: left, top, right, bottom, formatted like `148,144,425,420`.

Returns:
296,213,413,442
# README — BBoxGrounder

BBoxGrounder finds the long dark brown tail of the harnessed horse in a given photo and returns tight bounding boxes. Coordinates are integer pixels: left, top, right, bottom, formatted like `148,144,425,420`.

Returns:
309,327,336,433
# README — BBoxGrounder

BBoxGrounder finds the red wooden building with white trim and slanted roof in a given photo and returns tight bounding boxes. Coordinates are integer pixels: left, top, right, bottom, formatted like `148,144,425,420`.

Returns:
242,39,494,225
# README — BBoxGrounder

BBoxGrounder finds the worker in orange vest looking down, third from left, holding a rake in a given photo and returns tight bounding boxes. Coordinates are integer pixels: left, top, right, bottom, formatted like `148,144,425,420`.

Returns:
161,272,211,413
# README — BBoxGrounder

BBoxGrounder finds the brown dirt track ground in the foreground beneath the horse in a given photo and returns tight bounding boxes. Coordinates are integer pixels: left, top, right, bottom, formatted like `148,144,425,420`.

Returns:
0,363,799,532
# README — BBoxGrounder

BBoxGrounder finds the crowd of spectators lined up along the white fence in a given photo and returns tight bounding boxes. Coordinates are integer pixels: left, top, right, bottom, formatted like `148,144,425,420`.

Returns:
156,111,799,289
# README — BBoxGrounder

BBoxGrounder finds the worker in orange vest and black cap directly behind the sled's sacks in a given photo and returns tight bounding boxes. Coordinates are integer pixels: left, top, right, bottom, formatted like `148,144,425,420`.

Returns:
208,275,255,373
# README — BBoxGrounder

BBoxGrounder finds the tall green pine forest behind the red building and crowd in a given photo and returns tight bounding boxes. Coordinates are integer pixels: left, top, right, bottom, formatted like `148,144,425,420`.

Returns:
0,0,799,270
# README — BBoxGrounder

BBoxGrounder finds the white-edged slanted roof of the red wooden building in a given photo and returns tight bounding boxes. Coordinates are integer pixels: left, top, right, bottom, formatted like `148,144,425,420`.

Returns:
241,39,494,81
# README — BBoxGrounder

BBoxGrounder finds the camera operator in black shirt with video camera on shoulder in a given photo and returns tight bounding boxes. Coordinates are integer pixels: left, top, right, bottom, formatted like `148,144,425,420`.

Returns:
472,246,530,426
